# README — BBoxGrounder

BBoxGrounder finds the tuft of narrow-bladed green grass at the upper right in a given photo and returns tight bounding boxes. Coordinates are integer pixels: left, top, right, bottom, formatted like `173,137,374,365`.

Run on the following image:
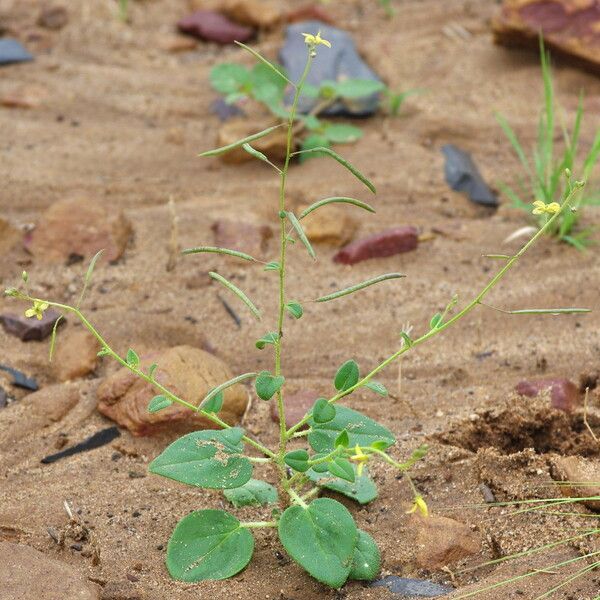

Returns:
496,37,600,250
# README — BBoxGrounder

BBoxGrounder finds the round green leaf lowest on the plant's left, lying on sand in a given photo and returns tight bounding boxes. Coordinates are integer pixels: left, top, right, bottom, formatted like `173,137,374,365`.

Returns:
167,510,254,582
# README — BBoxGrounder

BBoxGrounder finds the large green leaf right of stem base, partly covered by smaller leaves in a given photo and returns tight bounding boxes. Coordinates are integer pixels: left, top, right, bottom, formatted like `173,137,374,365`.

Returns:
308,406,396,452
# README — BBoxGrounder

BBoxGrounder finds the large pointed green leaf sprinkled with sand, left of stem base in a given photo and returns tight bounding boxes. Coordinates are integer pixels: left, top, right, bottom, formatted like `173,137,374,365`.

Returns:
148,427,252,489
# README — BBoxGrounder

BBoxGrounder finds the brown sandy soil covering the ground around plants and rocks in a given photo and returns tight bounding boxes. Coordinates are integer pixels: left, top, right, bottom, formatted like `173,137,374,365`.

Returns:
0,0,600,600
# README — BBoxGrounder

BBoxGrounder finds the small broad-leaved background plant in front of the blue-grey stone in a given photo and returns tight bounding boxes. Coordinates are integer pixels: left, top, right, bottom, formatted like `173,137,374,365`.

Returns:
210,44,419,160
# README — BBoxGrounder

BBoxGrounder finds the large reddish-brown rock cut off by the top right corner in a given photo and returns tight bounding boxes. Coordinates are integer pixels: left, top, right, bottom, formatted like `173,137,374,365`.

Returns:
493,0,600,71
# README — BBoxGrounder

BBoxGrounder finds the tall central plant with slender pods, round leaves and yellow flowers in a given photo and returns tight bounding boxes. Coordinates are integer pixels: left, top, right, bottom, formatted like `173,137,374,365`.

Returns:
6,35,586,588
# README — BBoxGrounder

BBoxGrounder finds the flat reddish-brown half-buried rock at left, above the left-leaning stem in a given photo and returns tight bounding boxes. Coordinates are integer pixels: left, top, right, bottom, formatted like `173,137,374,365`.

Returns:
24,199,132,263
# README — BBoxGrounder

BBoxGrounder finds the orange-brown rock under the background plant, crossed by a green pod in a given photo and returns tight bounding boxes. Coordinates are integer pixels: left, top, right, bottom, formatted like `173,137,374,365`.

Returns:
217,119,287,165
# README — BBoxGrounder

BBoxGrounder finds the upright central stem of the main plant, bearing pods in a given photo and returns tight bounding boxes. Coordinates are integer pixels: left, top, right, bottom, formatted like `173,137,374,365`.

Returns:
275,52,312,464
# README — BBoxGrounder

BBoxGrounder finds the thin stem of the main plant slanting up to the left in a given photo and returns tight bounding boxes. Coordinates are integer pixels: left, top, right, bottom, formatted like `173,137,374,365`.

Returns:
23,296,275,460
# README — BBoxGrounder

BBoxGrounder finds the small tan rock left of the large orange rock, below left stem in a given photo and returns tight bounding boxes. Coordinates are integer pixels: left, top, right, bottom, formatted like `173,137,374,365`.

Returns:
53,328,100,381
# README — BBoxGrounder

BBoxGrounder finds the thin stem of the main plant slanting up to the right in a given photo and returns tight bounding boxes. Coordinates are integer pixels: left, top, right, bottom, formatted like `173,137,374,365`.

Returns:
286,184,583,439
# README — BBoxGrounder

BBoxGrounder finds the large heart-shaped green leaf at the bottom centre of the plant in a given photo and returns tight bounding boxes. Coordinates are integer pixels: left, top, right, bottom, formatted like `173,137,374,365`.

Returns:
279,498,358,588
